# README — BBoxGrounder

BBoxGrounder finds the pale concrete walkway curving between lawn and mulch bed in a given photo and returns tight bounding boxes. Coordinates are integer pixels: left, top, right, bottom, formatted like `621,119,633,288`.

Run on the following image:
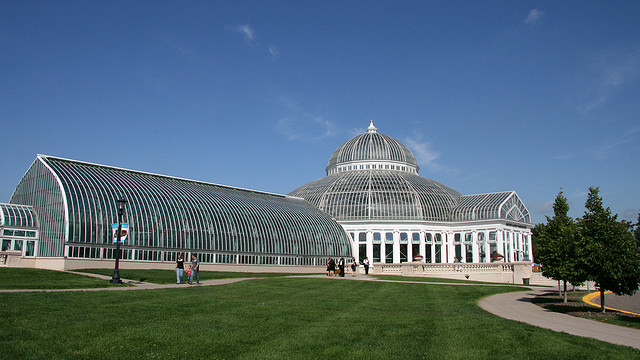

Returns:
478,289,640,349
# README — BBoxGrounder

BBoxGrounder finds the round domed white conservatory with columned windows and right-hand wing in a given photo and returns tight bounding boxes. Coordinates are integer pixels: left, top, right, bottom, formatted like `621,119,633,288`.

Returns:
289,121,533,264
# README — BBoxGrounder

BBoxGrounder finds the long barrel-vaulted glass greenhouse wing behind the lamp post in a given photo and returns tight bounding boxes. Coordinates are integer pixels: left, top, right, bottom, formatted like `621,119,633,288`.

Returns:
7,155,352,269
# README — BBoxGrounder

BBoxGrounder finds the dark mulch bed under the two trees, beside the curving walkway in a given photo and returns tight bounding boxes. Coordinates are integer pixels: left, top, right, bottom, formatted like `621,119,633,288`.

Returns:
531,291,640,329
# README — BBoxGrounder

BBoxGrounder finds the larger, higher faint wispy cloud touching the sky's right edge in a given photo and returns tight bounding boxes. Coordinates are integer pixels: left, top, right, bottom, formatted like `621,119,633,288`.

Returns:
578,49,640,113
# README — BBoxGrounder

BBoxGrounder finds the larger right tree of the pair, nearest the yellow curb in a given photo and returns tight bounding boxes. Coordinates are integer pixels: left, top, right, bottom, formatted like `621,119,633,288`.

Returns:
579,187,640,312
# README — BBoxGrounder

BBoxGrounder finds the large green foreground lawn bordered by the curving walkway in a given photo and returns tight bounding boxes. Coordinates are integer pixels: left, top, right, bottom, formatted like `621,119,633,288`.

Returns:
0,278,640,360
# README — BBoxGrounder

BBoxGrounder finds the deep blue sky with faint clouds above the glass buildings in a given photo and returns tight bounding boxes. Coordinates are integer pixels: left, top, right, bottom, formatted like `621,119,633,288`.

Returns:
0,1,640,223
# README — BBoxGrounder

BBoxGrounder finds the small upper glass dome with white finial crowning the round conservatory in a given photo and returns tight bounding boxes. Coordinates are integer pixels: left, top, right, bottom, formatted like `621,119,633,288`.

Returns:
326,120,419,174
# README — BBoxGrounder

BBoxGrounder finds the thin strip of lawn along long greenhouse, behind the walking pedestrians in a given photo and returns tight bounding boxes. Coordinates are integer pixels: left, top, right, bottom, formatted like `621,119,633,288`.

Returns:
77,269,312,284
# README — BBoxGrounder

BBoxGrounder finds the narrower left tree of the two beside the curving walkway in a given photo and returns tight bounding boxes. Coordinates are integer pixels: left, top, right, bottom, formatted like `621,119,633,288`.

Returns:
537,191,587,303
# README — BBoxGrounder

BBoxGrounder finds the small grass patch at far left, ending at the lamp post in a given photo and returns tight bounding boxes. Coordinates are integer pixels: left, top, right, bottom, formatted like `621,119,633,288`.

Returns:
0,268,113,290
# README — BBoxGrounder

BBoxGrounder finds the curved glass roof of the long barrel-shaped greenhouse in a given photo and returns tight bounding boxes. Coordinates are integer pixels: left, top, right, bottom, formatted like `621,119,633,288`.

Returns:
11,155,351,264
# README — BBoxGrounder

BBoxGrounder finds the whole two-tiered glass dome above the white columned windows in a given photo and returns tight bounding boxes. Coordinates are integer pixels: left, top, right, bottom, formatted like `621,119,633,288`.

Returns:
289,121,461,221
